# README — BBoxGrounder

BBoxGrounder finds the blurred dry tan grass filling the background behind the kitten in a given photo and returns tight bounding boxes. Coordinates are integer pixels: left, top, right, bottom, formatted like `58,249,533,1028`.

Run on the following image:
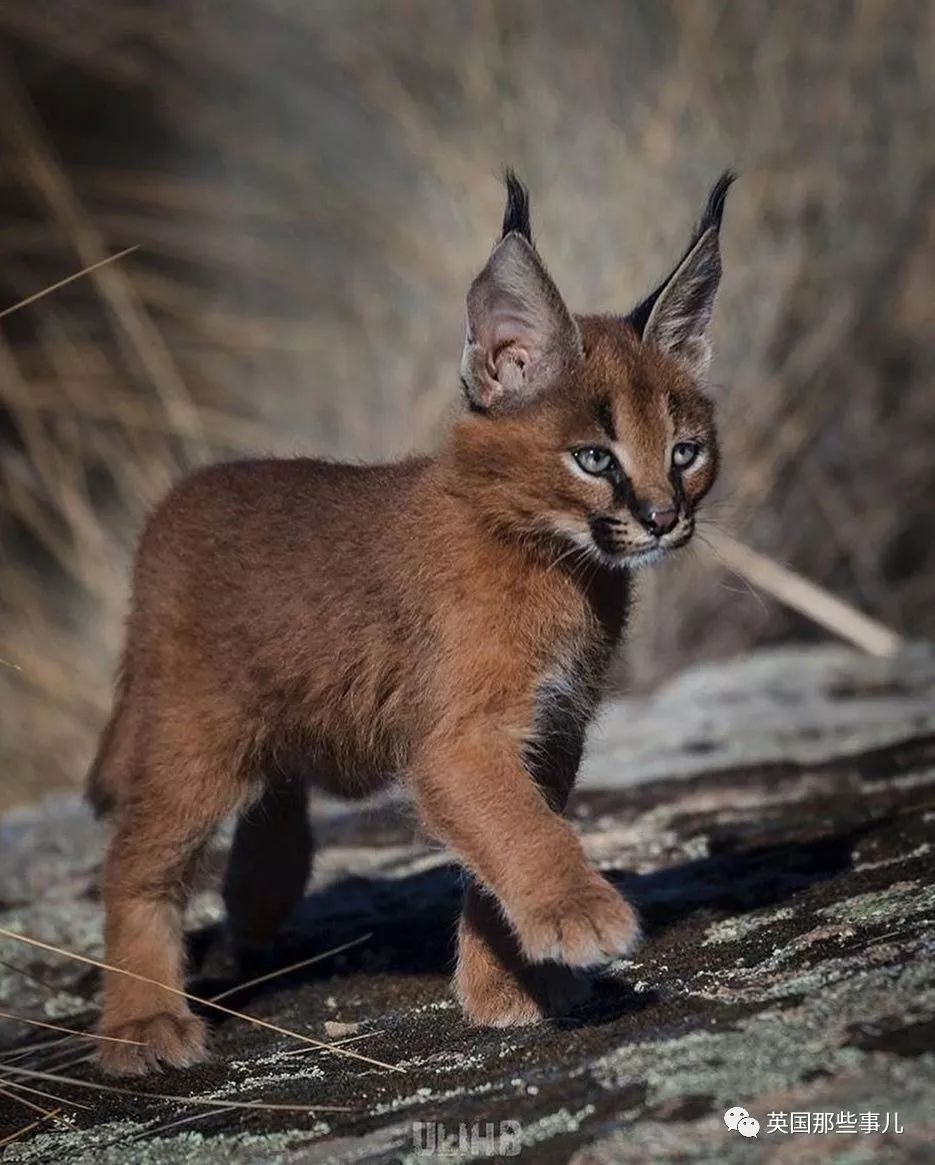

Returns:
0,0,935,804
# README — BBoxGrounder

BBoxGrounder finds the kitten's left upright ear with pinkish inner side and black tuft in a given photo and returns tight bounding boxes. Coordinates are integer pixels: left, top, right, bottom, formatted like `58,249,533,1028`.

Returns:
461,172,581,412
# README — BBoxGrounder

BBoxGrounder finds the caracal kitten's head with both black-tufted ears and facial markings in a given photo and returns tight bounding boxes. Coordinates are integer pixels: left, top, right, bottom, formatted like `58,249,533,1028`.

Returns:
452,174,732,566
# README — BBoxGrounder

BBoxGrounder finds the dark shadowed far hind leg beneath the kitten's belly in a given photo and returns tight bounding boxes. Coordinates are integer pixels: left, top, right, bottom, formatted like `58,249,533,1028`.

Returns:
224,777,313,955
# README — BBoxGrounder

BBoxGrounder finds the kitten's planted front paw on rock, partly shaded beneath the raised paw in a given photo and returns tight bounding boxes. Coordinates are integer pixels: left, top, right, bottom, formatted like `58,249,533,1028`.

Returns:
454,966,592,1028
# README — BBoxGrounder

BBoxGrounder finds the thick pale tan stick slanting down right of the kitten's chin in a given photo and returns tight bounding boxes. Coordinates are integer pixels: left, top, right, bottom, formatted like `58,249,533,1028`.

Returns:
706,530,904,657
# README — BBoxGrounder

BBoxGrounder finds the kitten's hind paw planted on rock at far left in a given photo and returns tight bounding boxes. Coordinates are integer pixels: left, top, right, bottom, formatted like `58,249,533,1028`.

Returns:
98,1011,207,1076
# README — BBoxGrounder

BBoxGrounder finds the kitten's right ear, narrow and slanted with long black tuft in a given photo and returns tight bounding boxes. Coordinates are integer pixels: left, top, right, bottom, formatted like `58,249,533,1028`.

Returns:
626,171,735,380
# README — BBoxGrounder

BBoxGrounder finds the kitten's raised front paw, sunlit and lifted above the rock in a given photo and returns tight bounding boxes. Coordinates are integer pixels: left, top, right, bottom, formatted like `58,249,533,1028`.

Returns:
511,871,639,967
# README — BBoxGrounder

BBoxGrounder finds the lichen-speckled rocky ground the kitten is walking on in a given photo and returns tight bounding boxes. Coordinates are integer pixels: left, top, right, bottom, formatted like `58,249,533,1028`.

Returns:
0,647,935,1165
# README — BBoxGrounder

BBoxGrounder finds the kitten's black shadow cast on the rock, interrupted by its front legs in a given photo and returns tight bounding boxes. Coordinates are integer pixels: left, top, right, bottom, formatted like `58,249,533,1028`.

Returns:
190,822,878,1023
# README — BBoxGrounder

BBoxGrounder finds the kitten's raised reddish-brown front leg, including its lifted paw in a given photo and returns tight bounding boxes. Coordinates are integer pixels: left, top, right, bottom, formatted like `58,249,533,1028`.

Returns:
413,730,639,967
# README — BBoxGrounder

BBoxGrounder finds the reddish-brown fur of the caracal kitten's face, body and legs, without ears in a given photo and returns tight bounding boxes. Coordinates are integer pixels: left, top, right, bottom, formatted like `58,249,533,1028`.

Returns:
90,172,731,1073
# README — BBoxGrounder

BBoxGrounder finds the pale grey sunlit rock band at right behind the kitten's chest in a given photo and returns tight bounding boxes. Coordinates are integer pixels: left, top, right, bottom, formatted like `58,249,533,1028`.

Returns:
581,643,935,788
